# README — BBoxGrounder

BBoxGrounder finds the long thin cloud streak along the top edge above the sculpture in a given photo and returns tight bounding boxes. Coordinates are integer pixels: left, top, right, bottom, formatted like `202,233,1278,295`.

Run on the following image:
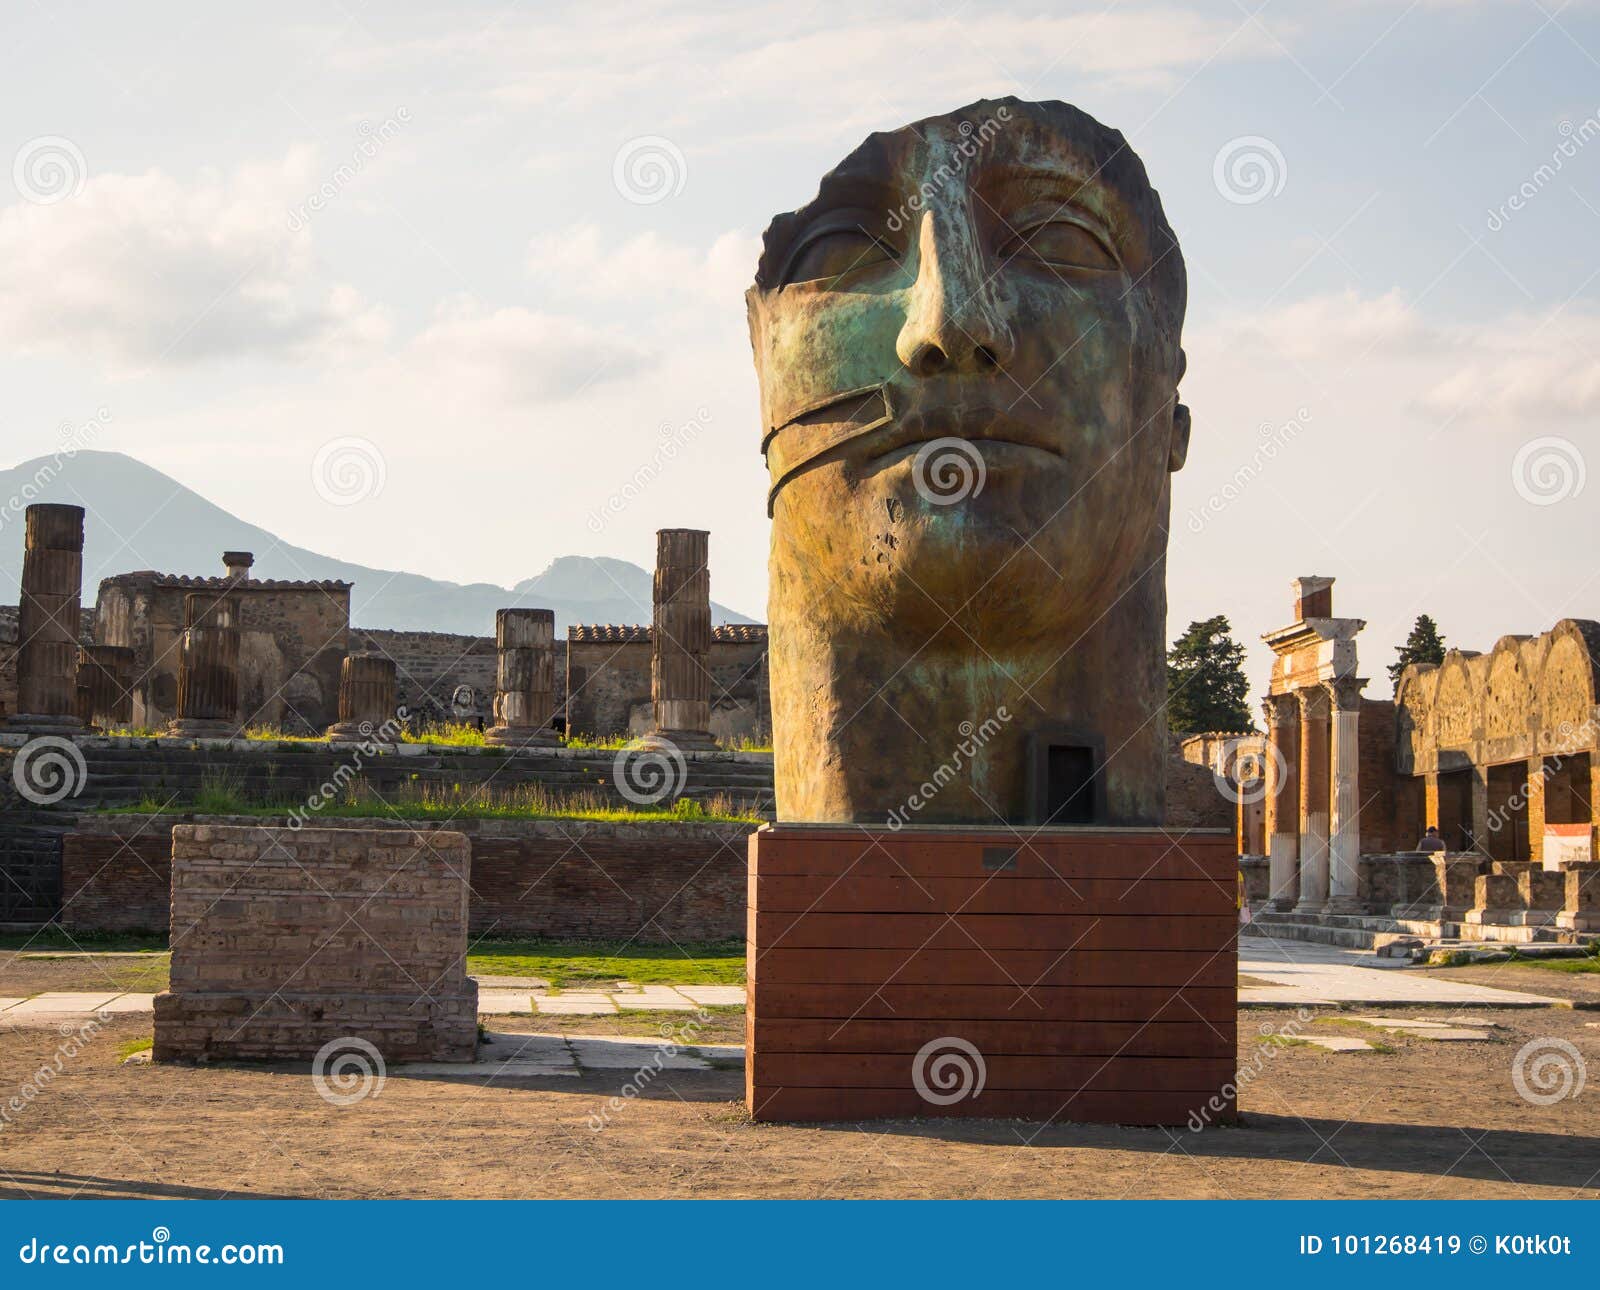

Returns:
333,3,1293,144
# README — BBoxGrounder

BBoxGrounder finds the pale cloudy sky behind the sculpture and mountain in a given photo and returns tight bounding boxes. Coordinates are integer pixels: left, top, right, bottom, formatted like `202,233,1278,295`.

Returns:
0,0,1600,698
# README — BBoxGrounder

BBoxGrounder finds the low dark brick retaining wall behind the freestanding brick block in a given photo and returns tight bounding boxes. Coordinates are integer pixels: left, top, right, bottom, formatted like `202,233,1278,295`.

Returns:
61,815,755,943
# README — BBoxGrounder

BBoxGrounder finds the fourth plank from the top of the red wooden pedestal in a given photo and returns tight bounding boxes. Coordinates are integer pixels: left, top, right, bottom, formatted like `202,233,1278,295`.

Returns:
750,941,1238,991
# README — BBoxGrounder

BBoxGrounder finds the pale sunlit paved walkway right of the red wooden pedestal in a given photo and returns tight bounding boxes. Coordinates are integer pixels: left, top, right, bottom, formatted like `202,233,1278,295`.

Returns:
1238,936,1563,1008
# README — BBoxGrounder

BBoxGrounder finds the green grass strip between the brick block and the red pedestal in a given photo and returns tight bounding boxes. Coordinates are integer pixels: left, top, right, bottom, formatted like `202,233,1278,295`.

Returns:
467,941,744,989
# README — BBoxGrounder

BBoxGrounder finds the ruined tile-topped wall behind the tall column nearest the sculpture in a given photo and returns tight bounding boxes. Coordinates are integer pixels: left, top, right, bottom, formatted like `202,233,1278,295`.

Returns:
557,623,773,743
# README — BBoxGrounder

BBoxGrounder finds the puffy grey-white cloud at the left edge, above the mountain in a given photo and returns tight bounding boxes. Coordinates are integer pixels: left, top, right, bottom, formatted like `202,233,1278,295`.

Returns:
0,149,389,373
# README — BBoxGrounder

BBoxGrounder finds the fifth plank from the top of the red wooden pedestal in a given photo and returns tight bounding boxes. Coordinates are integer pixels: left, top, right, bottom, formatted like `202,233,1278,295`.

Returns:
750,980,1237,1024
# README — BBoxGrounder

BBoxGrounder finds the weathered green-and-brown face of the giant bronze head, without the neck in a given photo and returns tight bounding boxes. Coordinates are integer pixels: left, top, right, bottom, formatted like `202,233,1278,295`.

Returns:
749,102,1187,645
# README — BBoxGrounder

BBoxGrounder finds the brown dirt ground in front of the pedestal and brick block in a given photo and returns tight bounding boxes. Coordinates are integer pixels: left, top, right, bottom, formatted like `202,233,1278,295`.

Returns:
0,968,1600,1197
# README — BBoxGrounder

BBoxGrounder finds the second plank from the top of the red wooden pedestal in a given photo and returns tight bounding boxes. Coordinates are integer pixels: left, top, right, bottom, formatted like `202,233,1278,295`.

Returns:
750,874,1237,917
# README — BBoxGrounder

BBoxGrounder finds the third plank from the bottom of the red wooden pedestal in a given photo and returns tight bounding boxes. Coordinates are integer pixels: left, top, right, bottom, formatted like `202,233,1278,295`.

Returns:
750,1018,1238,1058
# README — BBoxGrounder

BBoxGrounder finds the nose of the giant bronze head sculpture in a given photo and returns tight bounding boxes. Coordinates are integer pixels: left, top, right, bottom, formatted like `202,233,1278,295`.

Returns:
894,211,1016,376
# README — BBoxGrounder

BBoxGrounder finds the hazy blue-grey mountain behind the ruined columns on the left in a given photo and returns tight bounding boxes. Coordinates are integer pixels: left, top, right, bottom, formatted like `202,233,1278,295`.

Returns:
0,451,750,635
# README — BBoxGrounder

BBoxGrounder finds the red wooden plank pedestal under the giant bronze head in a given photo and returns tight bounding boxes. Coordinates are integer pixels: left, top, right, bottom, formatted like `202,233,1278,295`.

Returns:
746,824,1238,1124
